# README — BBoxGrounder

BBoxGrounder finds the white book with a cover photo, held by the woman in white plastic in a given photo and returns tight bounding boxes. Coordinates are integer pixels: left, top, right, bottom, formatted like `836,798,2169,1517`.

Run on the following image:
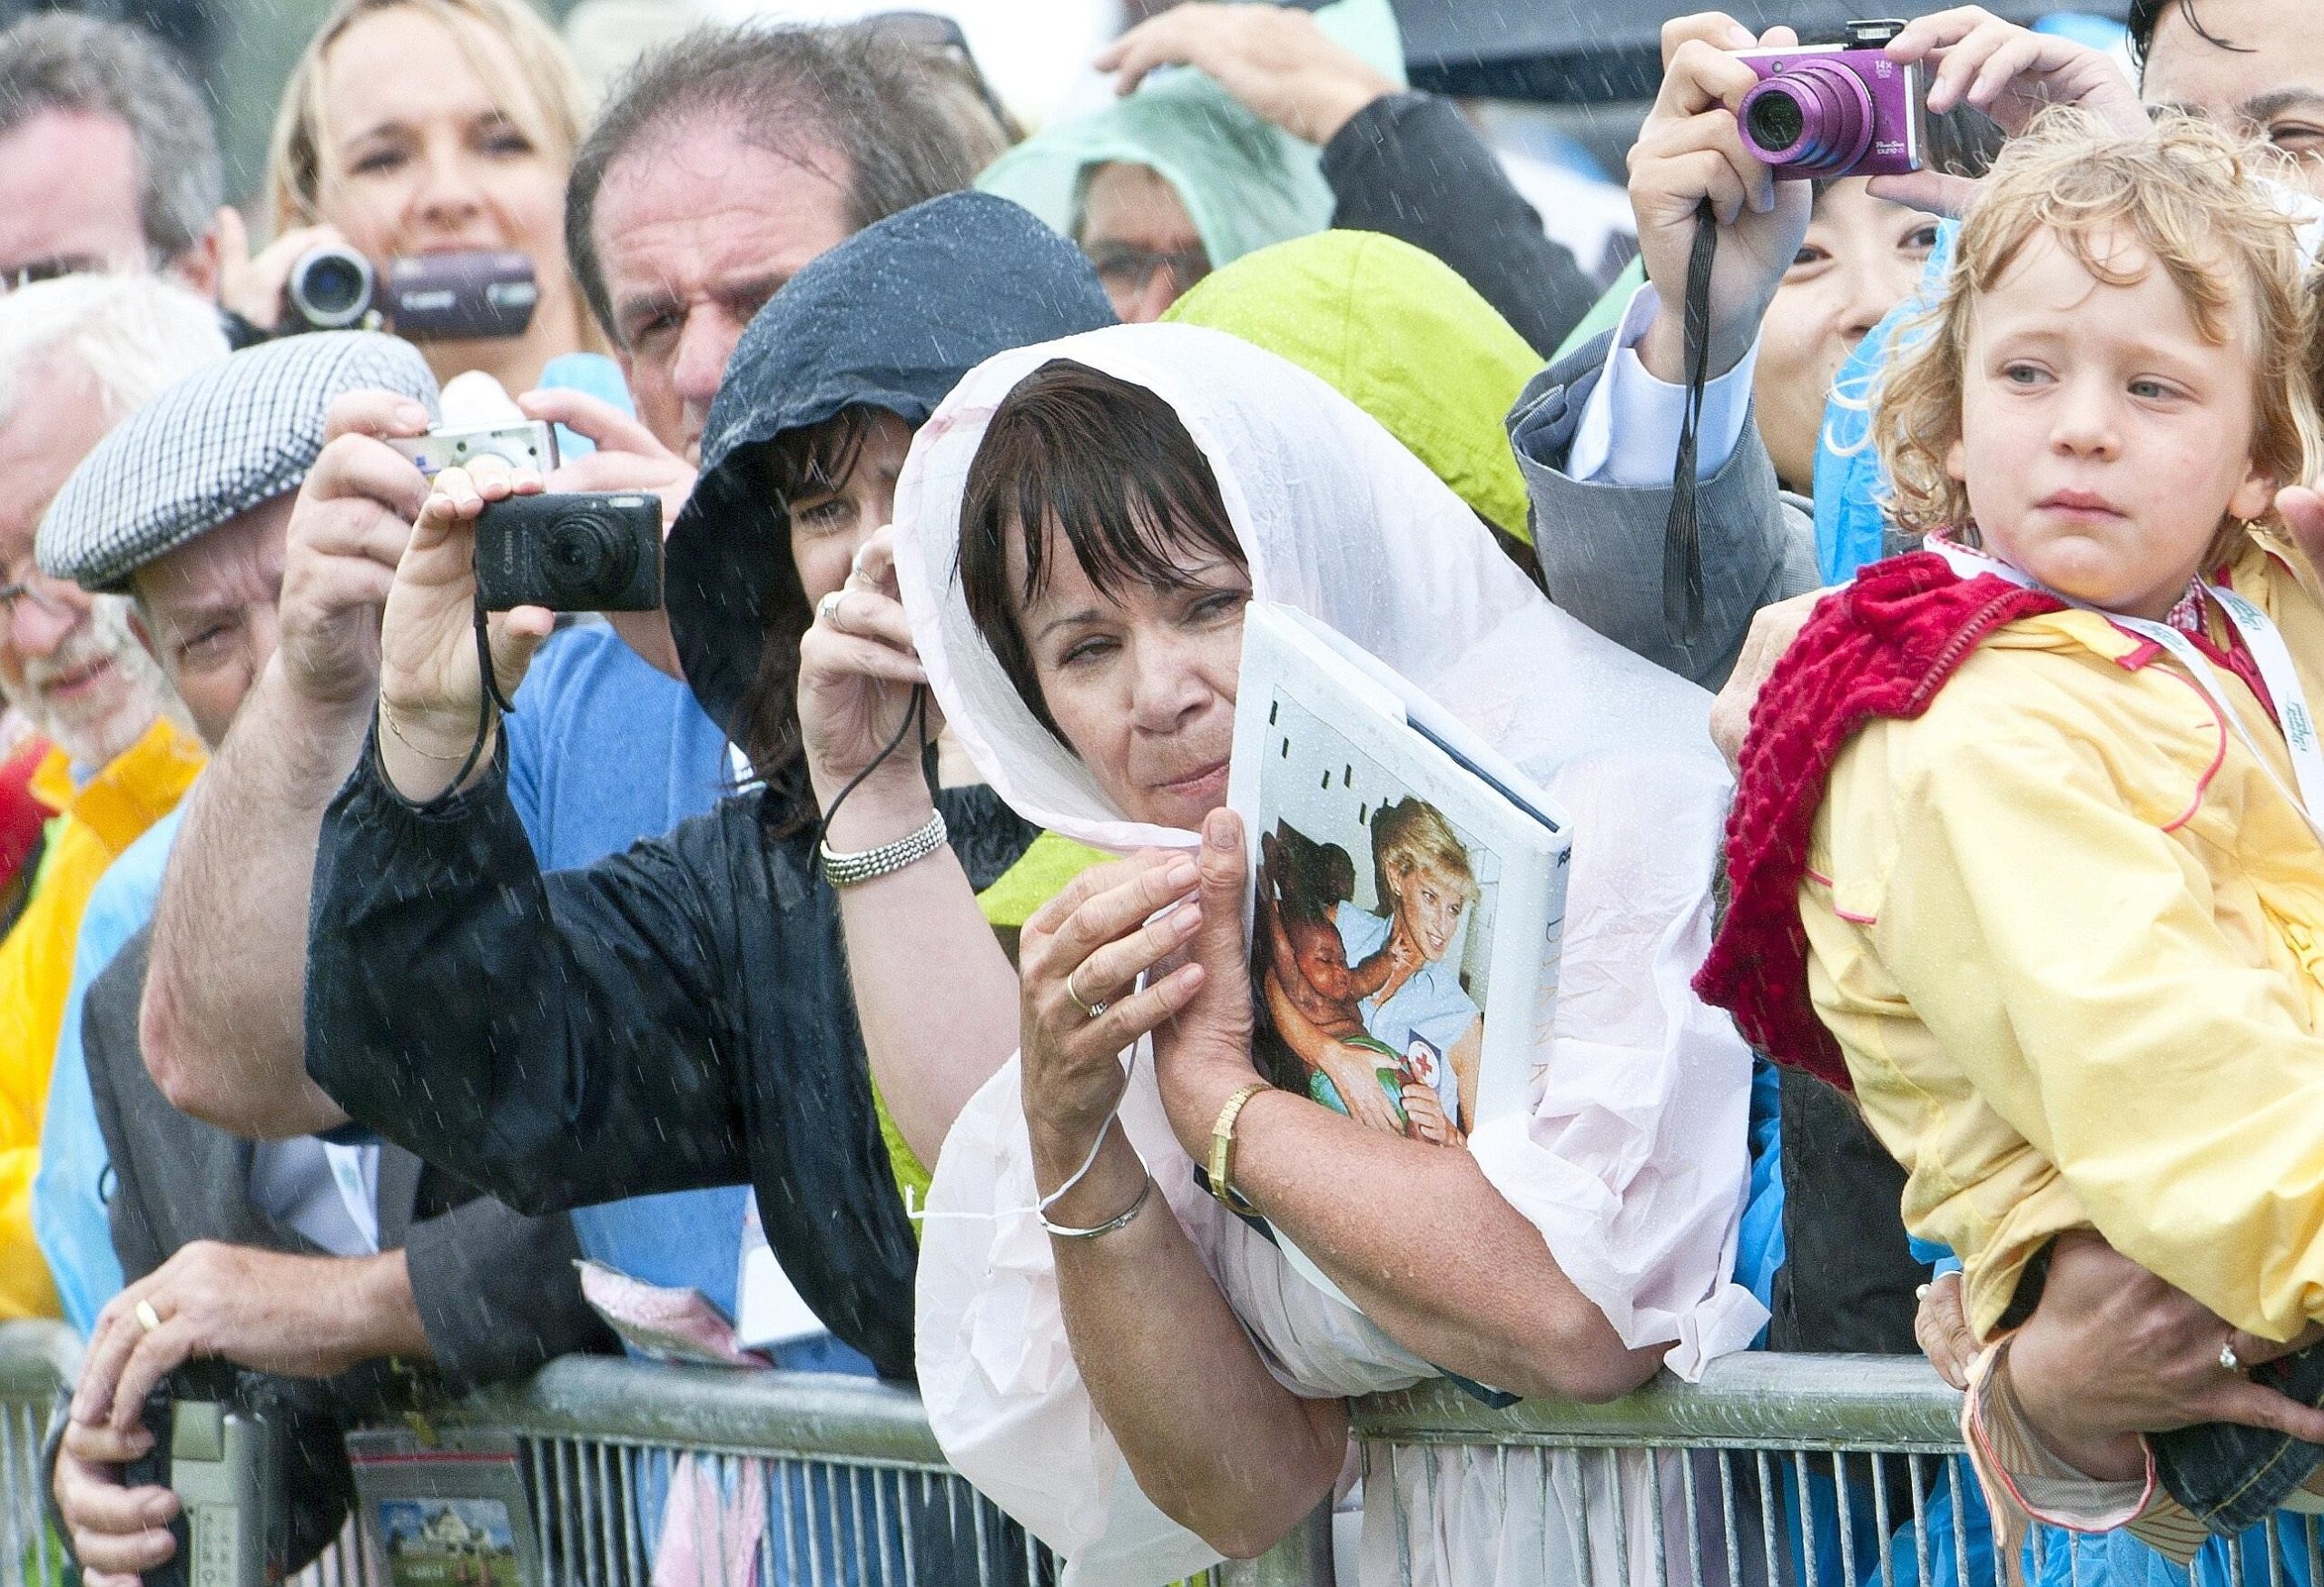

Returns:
1227,602,1571,1299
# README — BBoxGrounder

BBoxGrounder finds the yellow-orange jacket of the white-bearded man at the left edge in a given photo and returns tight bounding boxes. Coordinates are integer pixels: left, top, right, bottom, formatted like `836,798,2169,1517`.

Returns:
0,718,202,1320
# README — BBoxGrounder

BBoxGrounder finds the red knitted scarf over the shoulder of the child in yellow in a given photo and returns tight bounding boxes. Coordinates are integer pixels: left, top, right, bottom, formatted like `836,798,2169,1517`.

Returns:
1694,551,2063,1089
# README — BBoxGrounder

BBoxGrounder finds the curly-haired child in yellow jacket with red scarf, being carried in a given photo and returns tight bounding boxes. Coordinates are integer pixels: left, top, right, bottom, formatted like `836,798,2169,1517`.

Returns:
1701,116,2324,1541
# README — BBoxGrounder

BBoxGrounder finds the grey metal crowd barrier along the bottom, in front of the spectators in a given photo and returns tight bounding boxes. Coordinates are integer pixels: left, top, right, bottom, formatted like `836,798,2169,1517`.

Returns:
0,1325,2324,1587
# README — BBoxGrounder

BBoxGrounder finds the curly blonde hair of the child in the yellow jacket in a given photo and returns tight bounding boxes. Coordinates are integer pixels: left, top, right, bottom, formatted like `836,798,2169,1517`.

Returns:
1873,107,2324,567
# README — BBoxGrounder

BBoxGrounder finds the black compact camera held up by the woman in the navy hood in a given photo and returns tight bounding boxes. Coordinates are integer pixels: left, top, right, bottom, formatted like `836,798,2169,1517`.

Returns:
477,490,663,611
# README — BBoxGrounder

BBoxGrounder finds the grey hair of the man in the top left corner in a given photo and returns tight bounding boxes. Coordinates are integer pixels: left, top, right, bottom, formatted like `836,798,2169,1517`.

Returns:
0,12,225,267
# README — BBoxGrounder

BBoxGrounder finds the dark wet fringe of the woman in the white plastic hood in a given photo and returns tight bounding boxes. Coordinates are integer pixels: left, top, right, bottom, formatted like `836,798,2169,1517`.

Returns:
960,358,1250,748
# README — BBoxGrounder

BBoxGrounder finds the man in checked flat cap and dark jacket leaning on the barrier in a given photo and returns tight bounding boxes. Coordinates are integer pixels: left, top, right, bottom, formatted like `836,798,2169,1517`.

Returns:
37,332,609,1582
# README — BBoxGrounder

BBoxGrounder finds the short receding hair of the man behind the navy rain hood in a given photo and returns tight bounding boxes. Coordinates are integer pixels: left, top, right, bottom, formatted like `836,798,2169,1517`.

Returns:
565,25,995,344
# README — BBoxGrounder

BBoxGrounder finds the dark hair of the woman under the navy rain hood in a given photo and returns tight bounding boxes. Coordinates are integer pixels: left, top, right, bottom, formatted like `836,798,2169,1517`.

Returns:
737,407,876,783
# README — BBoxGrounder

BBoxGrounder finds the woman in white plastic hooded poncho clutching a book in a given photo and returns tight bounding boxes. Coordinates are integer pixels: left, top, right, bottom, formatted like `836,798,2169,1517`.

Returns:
895,325,1764,1587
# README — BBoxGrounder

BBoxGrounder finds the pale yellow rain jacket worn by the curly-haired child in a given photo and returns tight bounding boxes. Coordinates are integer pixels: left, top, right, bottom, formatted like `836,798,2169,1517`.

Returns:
1798,548,2324,1338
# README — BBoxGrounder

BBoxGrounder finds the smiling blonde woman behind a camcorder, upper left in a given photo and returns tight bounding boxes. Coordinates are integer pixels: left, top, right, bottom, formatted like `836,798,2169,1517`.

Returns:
225,0,605,393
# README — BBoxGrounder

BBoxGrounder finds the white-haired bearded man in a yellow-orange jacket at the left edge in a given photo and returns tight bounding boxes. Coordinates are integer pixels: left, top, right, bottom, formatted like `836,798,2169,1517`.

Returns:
0,274,225,1320
